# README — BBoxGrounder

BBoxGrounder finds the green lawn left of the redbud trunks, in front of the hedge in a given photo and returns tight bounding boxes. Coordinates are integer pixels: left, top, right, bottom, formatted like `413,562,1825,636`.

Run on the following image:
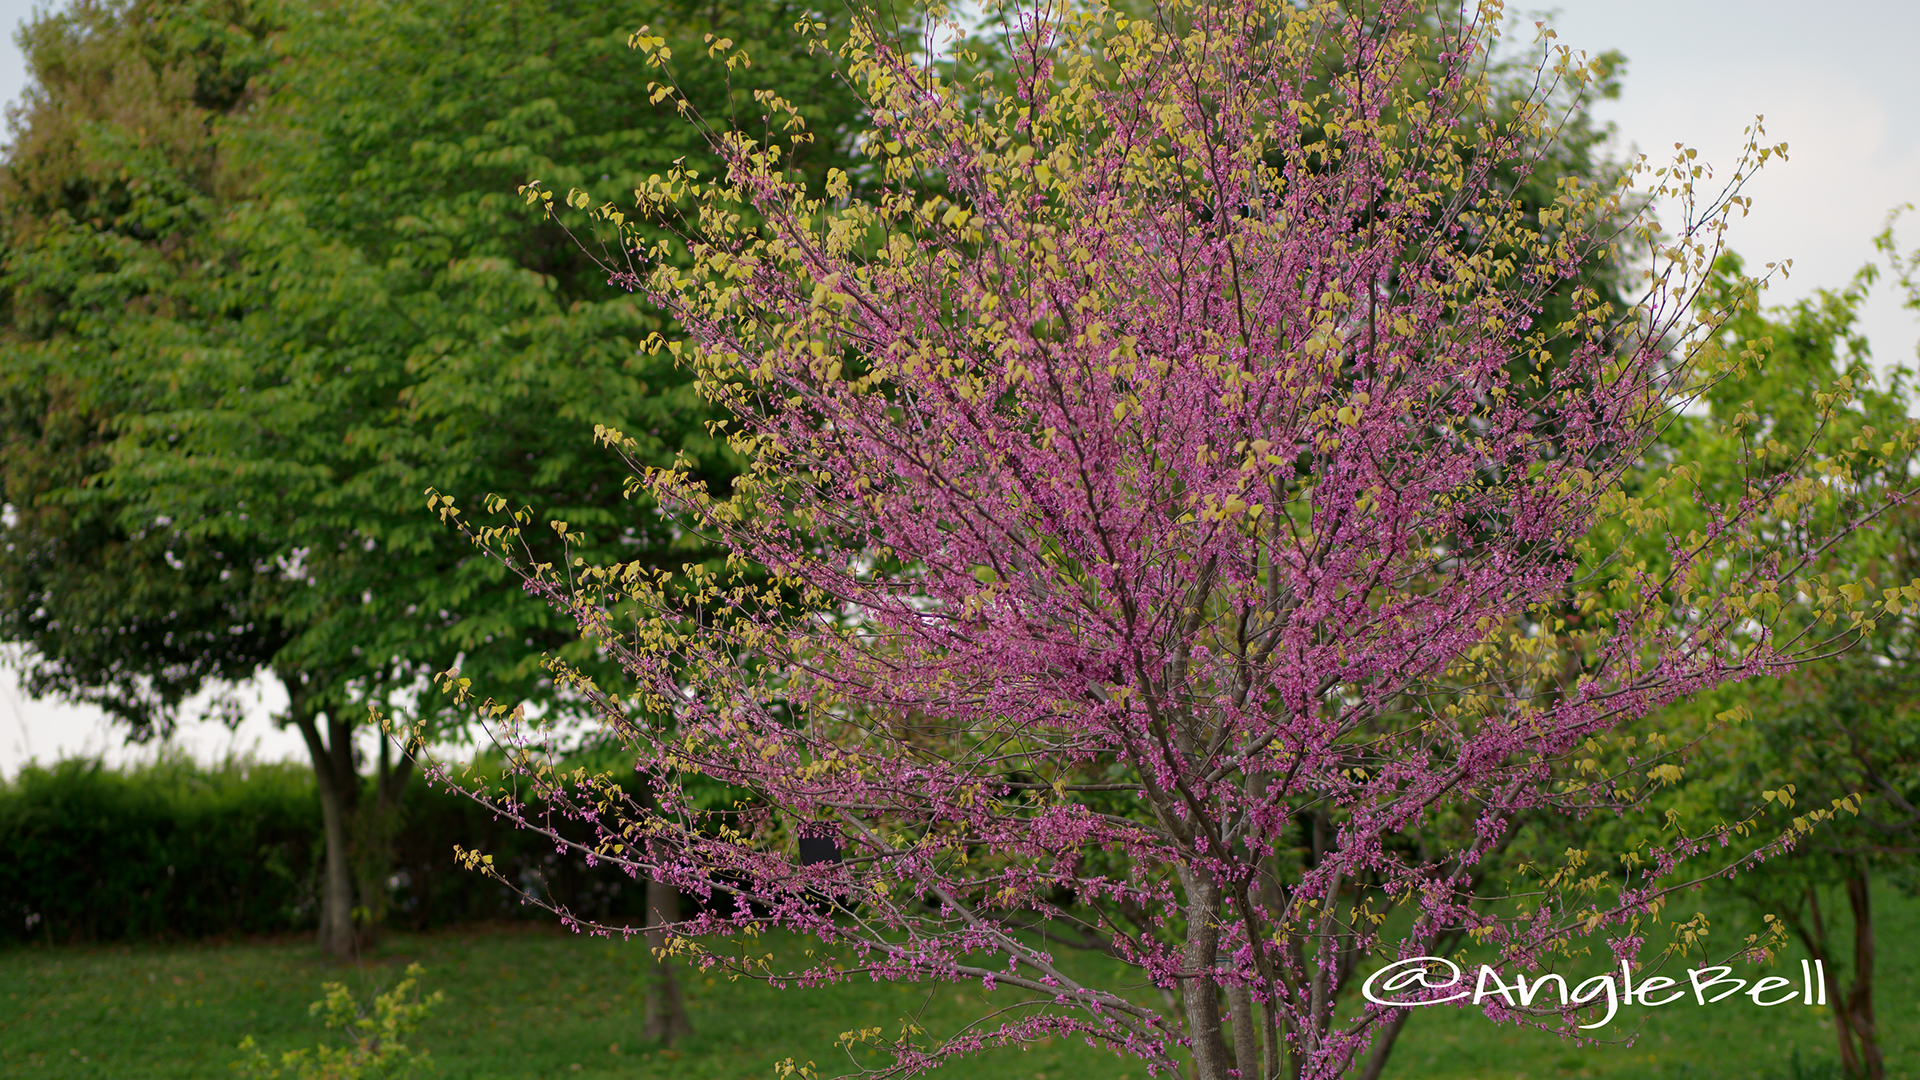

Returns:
0,914,1146,1080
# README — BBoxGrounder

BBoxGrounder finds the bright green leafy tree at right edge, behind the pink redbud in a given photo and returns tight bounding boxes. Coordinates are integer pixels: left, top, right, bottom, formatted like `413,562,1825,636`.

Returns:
1615,244,1920,1080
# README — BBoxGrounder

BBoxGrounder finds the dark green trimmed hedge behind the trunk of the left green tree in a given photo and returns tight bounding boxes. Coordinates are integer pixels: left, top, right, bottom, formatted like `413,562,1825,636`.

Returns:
0,759,645,942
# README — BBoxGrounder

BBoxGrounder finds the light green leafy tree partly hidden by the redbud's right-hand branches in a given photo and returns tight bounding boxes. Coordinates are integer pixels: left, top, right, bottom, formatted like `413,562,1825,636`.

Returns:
1559,247,1920,1078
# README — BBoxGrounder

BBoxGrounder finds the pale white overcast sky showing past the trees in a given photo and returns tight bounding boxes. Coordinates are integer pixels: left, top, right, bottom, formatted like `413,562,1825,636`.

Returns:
0,0,1920,776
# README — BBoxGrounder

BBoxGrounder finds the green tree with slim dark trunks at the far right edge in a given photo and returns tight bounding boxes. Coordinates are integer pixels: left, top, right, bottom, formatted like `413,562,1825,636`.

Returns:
1695,255,1920,1080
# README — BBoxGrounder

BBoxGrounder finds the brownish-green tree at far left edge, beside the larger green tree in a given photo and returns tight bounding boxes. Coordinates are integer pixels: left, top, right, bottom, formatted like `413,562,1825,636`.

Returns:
0,0,286,740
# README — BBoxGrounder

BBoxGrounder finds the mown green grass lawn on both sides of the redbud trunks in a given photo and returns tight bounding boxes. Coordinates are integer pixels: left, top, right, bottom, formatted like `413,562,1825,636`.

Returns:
0,880,1920,1080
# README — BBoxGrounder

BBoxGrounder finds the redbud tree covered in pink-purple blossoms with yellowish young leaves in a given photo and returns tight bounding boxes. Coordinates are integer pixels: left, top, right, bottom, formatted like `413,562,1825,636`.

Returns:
412,0,1920,1080
